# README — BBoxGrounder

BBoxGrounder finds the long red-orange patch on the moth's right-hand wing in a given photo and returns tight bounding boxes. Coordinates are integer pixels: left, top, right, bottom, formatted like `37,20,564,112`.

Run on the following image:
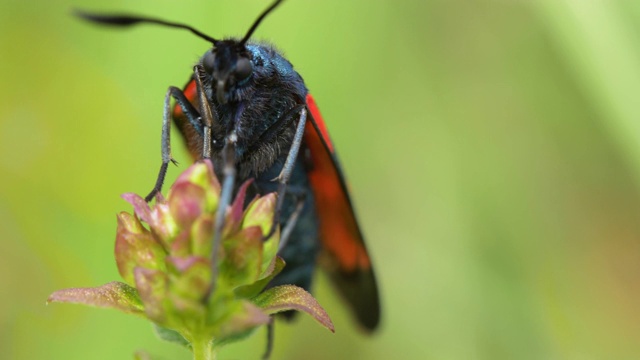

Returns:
304,95,371,273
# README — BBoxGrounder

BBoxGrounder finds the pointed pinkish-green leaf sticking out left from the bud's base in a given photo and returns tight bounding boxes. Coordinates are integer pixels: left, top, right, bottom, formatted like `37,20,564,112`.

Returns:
47,281,144,316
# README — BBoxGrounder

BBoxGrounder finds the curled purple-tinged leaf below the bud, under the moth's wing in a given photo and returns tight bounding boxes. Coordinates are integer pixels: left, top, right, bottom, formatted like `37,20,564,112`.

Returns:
252,285,335,332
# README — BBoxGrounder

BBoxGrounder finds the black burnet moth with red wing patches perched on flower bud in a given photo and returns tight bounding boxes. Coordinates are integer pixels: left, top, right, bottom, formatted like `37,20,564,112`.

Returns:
77,0,380,352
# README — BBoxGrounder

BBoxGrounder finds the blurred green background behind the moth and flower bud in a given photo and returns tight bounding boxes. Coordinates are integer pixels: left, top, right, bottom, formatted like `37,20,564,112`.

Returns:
0,0,640,360
